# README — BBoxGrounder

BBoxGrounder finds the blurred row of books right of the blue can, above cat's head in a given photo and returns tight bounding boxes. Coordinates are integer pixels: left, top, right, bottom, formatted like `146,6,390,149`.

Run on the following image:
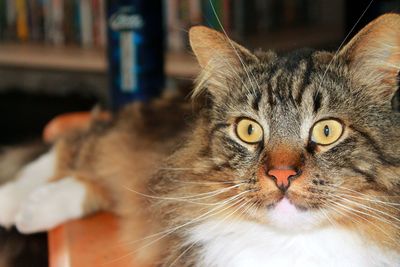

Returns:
164,0,344,51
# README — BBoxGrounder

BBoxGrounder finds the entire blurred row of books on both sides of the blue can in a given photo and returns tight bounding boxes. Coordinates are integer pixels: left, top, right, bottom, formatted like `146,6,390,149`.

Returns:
0,0,388,51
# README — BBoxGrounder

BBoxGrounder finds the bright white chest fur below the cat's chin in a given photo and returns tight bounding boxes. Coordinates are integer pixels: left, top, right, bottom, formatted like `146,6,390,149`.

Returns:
189,221,400,267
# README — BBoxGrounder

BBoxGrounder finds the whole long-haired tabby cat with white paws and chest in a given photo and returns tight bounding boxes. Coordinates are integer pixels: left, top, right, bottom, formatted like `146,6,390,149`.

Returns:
0,14,400,267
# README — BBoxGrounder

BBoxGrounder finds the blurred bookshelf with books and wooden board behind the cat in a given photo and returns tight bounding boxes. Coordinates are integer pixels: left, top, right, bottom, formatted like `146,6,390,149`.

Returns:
0,0,344,98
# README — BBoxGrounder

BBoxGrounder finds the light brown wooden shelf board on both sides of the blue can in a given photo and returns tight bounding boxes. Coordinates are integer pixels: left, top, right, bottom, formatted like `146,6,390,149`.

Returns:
0,43,199,78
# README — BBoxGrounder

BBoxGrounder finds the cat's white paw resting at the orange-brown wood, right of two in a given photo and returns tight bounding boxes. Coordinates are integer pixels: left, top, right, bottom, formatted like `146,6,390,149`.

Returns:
16,177,86,233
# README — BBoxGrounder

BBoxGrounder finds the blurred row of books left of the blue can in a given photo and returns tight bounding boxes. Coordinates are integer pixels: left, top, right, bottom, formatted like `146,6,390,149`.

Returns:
0,0,107,48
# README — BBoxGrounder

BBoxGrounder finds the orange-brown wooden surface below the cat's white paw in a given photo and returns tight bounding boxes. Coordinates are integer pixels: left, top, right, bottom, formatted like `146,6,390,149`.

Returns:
48,213,134,267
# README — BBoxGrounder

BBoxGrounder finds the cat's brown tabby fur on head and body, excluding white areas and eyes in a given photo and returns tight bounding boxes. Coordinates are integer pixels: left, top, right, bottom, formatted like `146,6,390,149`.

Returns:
43,14,400,266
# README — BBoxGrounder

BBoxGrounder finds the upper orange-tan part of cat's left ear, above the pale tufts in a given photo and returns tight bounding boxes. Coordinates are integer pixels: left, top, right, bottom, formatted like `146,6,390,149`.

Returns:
189,26,255,69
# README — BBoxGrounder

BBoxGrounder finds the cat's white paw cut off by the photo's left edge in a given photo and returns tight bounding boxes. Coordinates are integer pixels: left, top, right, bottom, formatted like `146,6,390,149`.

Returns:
0,183,23,228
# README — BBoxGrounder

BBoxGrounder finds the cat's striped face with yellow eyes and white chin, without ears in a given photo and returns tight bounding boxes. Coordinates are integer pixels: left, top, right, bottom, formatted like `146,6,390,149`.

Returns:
205,49,400,230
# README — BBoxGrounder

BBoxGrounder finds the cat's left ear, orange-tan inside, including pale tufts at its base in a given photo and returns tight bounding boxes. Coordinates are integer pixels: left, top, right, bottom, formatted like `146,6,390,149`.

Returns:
189,26,257,97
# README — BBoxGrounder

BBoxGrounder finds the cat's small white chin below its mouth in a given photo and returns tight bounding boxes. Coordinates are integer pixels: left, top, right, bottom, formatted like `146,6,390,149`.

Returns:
266,197,320,232
